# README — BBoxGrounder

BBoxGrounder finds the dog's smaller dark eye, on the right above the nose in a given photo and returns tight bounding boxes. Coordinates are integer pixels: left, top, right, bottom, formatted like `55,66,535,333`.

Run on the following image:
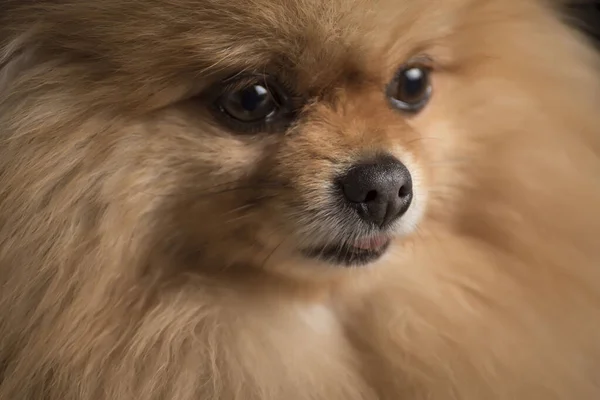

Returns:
387,65,432,113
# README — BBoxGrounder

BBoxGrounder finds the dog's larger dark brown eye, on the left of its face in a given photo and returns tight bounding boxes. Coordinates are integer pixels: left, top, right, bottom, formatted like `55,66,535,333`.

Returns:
214,76,296,133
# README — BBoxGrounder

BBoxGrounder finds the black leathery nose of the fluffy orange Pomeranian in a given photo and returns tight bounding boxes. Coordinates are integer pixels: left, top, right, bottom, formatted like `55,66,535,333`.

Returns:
340,156,413,227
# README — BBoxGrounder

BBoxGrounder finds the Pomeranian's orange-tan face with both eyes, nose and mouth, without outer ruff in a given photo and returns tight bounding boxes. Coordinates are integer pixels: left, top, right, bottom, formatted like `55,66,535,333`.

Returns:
108,2,446,274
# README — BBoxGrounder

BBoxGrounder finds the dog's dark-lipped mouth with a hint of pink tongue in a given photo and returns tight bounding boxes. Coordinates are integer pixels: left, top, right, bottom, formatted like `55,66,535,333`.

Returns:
304,235,391,267
